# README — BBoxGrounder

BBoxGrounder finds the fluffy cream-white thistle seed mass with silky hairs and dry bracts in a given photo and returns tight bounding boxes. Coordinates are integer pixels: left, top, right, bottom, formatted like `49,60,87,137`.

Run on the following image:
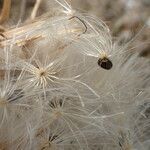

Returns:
0,0,150,150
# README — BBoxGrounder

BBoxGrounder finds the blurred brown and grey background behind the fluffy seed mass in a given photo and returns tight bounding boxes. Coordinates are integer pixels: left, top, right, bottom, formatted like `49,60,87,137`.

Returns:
0,0,150,57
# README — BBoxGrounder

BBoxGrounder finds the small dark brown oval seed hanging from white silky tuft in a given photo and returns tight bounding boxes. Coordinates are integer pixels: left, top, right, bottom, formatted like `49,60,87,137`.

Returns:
97,57,113,70
